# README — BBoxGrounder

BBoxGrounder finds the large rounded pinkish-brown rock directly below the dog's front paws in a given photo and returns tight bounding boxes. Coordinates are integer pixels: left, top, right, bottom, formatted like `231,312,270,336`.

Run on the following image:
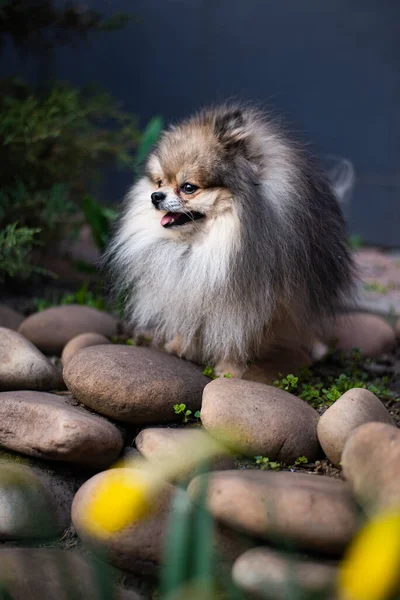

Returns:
201,379,320,463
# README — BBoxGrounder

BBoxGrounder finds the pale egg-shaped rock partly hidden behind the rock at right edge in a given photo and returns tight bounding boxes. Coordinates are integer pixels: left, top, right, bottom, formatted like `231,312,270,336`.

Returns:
317,388,394,465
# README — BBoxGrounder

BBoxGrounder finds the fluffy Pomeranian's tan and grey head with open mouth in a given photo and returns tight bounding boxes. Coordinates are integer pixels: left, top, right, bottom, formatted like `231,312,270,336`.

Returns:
146,108,261,233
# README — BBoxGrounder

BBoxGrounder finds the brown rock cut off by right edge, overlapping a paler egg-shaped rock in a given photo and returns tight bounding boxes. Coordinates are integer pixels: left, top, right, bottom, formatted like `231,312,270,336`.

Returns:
342,423,400,514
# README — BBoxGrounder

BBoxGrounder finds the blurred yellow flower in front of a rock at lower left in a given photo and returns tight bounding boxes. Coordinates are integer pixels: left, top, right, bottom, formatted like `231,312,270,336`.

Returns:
85,469,160,536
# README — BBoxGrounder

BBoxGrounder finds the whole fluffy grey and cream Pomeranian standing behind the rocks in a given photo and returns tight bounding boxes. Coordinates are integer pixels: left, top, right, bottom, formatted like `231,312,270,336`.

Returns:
108,105,352,377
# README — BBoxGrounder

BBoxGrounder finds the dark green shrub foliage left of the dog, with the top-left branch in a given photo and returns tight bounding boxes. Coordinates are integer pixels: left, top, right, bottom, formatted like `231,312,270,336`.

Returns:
0,0,162,277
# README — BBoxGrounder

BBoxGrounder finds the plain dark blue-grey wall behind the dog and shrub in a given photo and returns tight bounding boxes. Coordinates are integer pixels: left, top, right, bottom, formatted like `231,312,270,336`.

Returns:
6,0,400,246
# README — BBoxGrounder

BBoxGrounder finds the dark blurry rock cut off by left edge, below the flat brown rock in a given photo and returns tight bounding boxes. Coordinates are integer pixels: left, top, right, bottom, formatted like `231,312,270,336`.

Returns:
0,462,74,541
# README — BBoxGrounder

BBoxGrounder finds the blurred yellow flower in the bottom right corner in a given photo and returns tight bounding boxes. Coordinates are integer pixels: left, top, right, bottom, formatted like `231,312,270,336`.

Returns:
338,510,400,600
